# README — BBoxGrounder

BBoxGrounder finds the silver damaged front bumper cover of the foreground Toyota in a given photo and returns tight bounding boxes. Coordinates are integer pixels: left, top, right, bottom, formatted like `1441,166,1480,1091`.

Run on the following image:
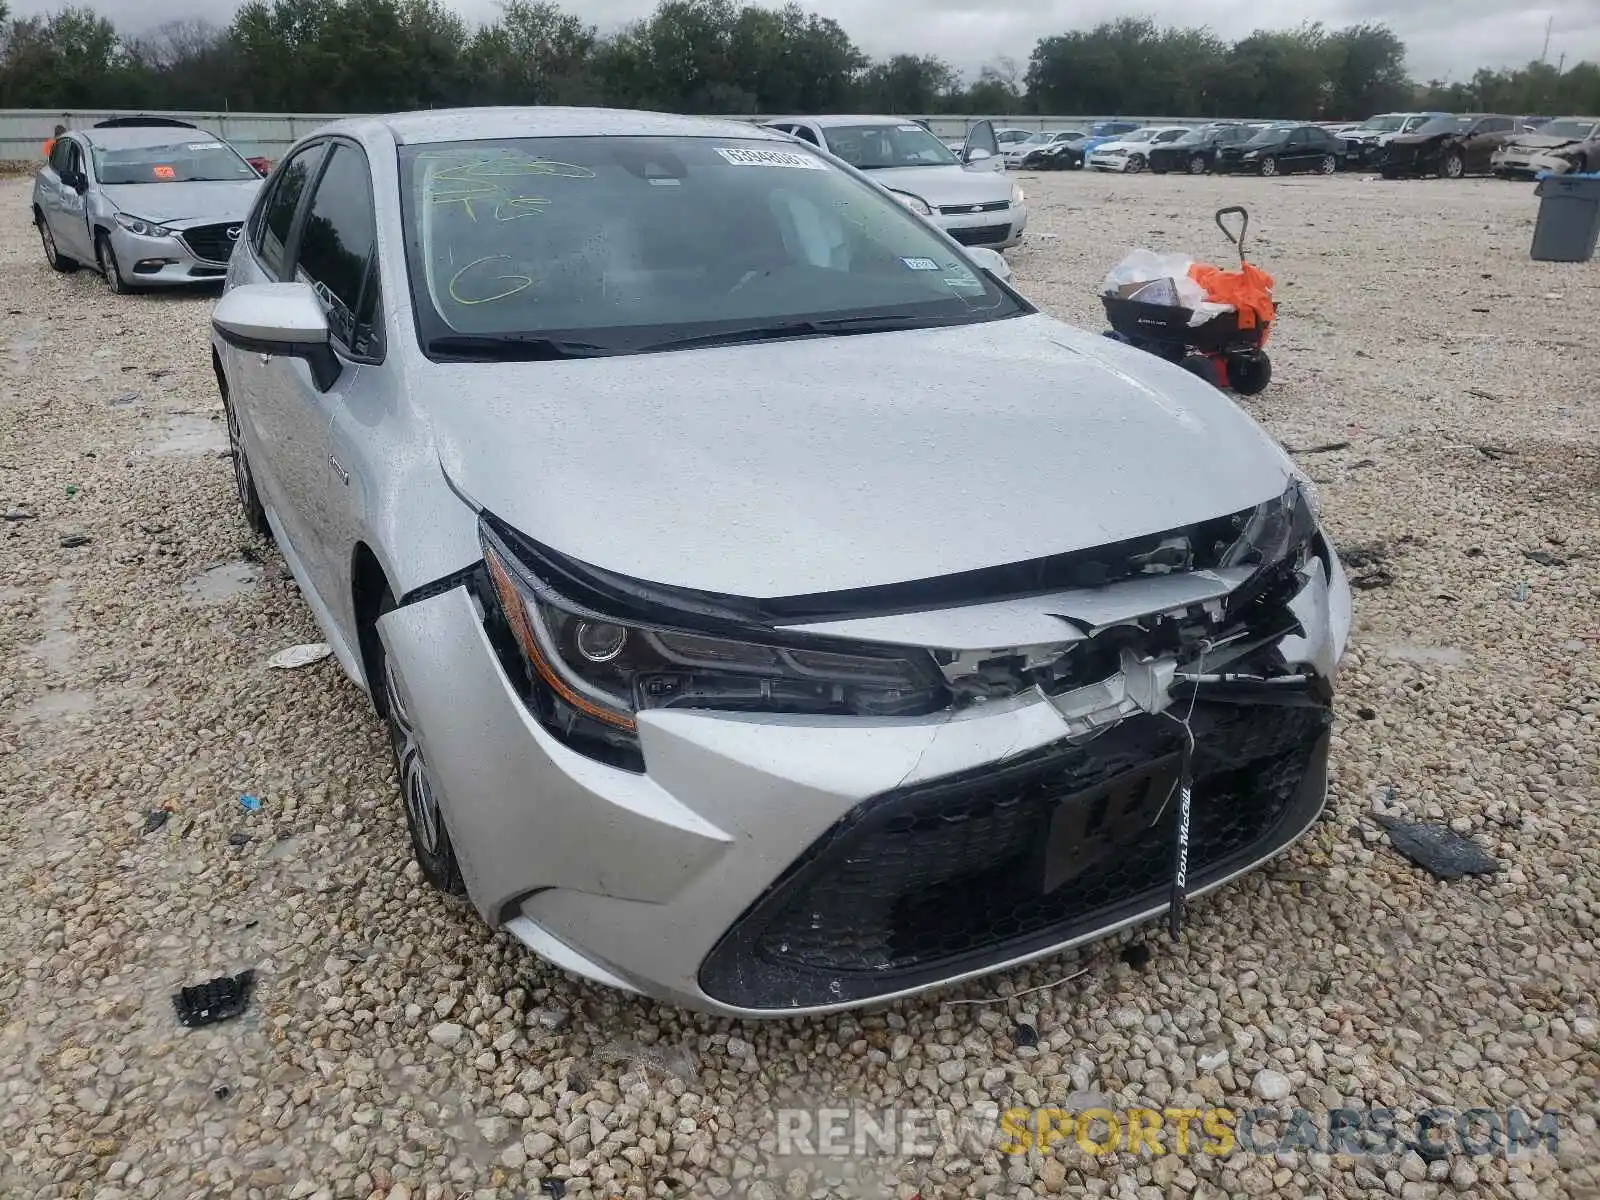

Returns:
379,524,1350,1016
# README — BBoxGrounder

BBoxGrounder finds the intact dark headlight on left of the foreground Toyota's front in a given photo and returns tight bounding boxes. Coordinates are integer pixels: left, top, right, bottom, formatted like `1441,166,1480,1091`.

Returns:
478,523,949,754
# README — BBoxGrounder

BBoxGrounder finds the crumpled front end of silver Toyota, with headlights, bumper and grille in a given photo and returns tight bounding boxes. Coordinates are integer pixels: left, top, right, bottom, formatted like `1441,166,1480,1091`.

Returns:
381,485,1350,1016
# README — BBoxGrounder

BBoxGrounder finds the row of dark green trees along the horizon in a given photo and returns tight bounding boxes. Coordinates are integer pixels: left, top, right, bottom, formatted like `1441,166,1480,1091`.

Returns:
0,0,1600,120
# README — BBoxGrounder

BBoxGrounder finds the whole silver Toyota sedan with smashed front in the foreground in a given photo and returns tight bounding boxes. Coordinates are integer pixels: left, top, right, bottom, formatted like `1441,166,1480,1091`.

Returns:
213,109,1350,1014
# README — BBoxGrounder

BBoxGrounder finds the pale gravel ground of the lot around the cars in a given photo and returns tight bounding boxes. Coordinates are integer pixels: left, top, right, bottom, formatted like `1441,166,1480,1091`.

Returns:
0,173,1600,1200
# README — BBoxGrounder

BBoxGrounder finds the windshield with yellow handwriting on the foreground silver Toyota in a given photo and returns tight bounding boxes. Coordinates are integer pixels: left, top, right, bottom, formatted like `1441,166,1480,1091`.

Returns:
400,138,1027,357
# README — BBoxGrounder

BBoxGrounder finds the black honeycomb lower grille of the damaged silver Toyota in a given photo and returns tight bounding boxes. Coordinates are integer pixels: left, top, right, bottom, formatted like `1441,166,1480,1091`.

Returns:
701,693,1331,1010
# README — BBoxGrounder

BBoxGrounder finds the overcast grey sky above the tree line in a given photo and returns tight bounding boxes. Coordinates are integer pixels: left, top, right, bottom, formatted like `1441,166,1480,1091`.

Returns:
11,0,1600,80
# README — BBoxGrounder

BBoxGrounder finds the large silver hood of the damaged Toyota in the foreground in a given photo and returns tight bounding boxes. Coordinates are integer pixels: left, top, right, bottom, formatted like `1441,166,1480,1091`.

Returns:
428,315,1291,598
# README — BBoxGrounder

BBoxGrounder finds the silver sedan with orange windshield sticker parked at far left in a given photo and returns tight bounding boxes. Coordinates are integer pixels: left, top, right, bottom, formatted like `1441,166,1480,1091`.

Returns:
34,118,261,293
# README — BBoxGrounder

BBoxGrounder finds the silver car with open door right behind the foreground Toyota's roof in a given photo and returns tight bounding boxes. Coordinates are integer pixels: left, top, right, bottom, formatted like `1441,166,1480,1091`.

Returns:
766,117,1027,250
